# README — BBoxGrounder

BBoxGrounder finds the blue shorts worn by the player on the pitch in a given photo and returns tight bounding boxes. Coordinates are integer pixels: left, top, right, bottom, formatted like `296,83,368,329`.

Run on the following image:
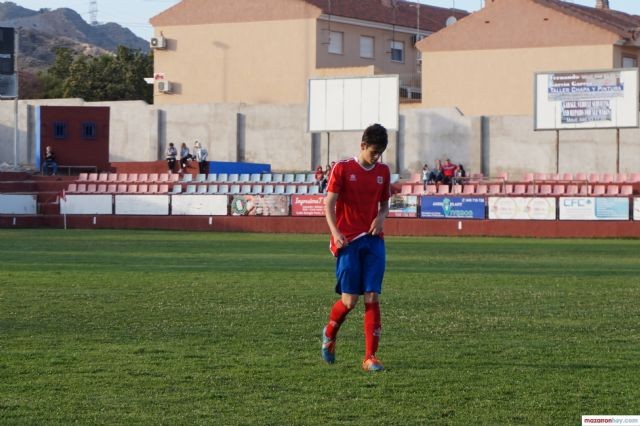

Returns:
336,235,386,294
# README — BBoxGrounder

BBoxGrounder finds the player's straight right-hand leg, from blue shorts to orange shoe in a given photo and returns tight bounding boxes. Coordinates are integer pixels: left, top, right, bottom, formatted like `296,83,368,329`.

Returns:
362,237,385,371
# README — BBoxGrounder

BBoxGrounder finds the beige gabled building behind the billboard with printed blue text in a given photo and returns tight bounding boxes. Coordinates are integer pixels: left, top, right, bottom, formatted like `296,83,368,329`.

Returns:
417,0,640,115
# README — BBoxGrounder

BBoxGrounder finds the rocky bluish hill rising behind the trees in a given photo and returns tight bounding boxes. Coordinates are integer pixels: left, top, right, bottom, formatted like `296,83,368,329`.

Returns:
0,1,149,71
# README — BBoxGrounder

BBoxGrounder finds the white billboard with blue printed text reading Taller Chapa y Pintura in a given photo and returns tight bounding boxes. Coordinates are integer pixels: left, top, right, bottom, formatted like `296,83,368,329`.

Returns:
534,68,638,130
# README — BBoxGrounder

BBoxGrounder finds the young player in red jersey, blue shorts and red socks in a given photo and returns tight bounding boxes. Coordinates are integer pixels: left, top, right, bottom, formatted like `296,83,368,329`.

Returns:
322,124,391,371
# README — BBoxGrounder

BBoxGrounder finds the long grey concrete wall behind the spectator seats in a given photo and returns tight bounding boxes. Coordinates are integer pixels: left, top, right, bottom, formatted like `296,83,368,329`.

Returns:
0,99,640,179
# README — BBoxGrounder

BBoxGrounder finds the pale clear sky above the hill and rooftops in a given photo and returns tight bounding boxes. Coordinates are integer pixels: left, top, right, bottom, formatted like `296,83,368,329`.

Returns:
8,0,640,40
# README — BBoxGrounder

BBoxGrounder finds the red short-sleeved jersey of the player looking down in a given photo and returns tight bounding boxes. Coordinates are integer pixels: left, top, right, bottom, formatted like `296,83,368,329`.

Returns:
327,158,391,256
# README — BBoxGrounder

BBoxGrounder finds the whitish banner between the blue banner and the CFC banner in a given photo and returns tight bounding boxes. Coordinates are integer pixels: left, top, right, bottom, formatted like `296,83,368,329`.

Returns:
489,197,556,220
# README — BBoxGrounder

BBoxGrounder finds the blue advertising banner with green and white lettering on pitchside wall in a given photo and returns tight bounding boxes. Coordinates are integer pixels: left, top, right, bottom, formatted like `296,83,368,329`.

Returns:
420,195,485,219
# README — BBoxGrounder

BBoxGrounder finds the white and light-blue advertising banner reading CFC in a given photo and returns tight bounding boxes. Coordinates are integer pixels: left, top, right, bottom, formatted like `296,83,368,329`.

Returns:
560,197,629,220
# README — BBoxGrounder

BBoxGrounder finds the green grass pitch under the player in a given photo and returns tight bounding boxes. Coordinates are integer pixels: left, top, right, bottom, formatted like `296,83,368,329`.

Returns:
0,229,640,425
